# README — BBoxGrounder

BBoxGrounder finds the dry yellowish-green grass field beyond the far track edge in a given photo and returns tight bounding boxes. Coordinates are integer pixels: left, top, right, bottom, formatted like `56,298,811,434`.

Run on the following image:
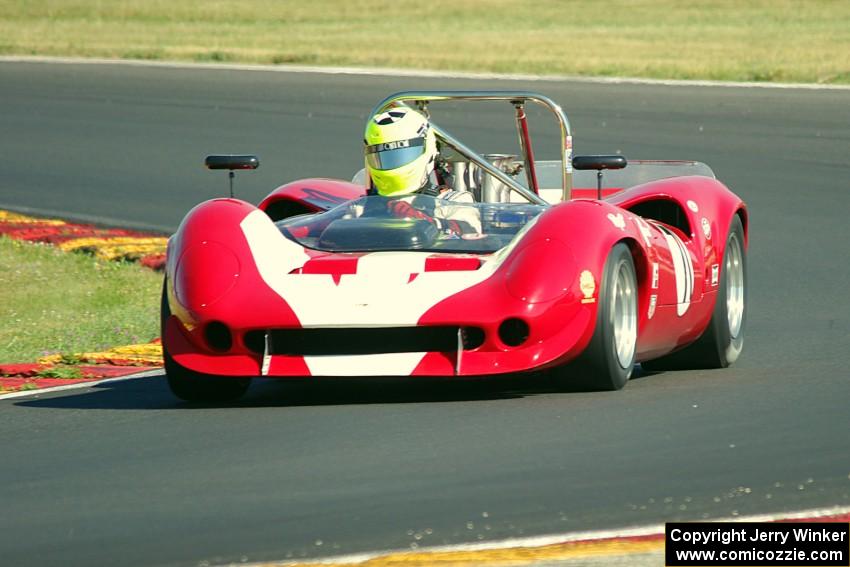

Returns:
0,0,850,83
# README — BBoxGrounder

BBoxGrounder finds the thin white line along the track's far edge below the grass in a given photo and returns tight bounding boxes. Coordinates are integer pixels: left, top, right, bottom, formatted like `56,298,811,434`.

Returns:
0,55,850,91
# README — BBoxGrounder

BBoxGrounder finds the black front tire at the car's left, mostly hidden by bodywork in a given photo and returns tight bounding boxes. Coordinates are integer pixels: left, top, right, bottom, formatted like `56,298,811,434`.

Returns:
160,280,251,402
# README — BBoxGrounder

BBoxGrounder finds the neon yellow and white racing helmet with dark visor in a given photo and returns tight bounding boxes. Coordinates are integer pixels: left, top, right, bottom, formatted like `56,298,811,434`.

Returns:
363,106,437,197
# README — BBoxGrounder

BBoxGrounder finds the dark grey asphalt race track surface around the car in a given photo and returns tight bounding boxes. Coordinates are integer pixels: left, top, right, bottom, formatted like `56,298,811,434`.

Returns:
0,63,850,565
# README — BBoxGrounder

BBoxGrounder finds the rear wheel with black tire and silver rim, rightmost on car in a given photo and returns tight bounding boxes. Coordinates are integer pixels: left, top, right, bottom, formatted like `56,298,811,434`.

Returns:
641,215,747,371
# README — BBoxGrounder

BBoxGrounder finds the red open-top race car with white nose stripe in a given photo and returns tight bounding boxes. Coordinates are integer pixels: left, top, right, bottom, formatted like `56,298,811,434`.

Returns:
161,92,748,400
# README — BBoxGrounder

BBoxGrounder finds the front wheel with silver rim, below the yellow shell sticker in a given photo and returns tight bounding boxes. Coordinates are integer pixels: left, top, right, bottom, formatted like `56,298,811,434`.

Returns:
552,242,638,390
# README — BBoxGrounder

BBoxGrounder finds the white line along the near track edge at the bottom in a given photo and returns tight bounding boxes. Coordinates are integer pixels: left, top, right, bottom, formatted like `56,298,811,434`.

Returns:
248,506,850,567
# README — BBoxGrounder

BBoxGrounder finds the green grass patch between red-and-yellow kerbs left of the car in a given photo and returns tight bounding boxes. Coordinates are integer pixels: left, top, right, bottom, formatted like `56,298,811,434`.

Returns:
0,237,162,363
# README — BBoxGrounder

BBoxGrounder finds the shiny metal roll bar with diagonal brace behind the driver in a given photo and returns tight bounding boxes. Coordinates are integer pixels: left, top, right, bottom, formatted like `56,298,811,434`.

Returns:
370,91,573,205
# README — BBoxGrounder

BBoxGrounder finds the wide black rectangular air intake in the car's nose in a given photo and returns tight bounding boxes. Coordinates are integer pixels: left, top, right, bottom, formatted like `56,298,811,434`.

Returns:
244,326,480,356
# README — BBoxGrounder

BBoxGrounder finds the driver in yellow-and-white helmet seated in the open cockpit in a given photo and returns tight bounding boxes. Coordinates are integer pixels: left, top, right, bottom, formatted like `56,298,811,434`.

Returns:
363,106,481,235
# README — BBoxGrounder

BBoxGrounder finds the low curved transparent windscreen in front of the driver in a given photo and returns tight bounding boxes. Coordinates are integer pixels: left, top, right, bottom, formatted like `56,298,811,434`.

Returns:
275,195,545,254
